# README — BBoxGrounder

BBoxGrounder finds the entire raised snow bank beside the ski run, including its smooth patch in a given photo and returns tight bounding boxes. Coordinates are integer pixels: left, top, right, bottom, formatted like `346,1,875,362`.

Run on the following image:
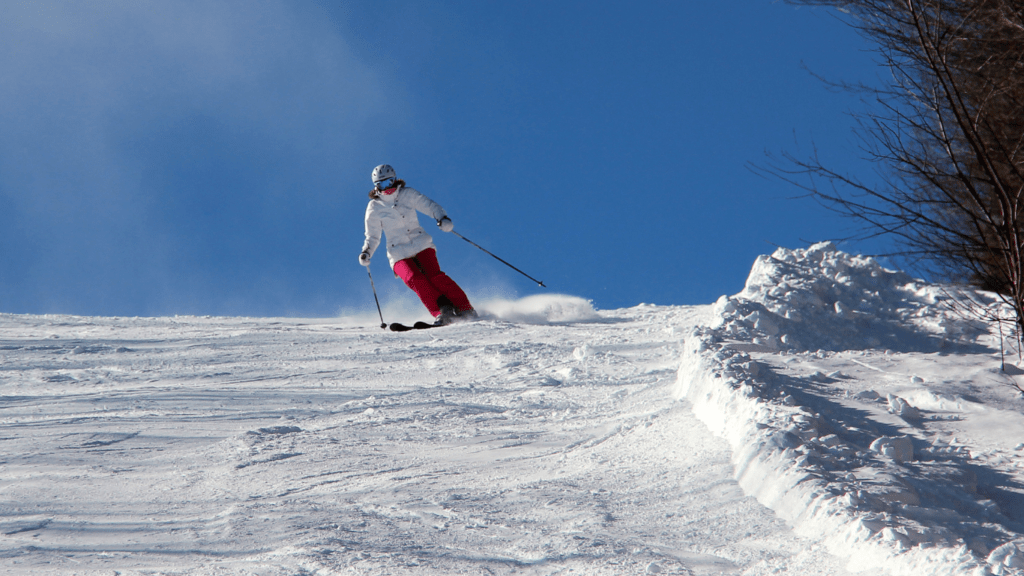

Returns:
676,243,1024,574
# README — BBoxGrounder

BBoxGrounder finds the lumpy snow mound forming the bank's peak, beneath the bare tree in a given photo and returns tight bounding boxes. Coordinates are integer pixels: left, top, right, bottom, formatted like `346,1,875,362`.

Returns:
716,237,996,352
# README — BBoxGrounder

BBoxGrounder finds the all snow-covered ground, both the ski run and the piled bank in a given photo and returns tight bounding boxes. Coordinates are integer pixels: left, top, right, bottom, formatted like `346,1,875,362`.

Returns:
0,243,1024,575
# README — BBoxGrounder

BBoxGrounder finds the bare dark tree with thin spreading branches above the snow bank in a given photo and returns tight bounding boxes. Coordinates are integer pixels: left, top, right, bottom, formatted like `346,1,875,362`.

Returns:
752,0,1024,334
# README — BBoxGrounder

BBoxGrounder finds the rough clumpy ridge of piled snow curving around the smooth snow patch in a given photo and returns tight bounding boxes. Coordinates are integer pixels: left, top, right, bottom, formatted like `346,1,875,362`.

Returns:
675,243,1024,575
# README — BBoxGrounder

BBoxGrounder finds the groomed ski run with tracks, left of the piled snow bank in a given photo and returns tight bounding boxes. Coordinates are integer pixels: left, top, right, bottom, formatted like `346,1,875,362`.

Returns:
0,296,860,575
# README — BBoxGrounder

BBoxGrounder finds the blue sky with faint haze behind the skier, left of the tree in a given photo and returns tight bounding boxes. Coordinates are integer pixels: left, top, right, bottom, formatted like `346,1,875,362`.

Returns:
0,0,879,320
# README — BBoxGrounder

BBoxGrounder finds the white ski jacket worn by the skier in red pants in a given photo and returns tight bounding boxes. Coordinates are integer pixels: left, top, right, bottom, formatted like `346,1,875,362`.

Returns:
362,187,447,269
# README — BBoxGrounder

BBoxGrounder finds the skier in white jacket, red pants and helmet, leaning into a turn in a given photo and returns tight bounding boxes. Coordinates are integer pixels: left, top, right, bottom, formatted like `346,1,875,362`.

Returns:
359,164,476,326
